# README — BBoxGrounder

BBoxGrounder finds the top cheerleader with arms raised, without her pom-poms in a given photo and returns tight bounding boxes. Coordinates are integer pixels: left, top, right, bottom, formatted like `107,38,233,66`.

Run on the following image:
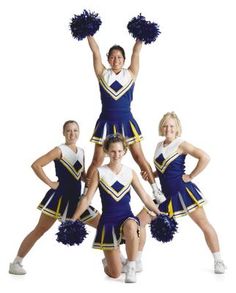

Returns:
84,36,165,202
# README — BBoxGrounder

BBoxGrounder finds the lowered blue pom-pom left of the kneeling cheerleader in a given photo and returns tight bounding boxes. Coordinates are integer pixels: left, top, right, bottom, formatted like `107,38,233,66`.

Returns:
56,221,88,246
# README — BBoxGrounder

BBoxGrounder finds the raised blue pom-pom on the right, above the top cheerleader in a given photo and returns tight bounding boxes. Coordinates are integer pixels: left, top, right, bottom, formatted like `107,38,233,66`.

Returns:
127,13,161,44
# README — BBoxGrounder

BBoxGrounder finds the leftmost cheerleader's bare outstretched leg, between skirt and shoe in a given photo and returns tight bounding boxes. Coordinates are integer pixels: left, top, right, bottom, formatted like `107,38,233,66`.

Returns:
17,214,56,258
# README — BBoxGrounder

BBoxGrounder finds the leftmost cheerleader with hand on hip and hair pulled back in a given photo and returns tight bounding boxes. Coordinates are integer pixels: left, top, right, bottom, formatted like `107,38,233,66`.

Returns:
9,120,100,275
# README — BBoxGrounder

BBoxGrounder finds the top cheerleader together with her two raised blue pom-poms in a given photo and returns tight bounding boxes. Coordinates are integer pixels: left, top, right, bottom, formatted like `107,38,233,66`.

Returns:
70,11,165,212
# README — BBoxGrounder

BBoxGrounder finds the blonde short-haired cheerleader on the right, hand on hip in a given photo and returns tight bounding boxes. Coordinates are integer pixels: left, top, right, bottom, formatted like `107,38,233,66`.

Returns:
143,112,226,274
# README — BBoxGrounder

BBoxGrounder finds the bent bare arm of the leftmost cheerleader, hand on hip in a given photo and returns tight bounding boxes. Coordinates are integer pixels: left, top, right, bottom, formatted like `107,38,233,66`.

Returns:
31,147,61,189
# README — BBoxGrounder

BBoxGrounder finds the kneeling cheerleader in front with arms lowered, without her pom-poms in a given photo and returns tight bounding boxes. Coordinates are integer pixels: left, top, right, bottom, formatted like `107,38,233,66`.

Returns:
73,133,159,283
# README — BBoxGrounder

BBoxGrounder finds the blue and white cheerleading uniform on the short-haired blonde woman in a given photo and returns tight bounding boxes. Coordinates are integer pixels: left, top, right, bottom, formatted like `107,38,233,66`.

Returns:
154,138,205,217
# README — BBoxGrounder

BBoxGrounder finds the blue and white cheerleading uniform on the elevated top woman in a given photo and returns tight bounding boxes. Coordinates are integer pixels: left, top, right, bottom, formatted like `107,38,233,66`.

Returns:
91,69,143,144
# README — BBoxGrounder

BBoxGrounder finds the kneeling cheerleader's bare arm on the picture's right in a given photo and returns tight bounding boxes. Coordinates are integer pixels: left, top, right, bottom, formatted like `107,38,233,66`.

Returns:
132,171,160,215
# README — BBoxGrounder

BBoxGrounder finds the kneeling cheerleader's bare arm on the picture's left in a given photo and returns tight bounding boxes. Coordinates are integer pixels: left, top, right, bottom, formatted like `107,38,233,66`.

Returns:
72,172,98,220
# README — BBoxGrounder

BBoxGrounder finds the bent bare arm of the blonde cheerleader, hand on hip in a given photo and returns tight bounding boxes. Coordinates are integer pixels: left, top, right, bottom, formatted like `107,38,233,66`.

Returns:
179,142,210,182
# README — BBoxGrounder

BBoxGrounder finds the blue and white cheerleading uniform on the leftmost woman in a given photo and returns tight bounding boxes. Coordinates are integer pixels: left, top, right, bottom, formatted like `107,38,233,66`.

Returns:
38,144,98,223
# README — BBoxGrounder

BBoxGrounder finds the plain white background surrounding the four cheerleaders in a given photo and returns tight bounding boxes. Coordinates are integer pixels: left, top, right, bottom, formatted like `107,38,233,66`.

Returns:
0,0,236,293
